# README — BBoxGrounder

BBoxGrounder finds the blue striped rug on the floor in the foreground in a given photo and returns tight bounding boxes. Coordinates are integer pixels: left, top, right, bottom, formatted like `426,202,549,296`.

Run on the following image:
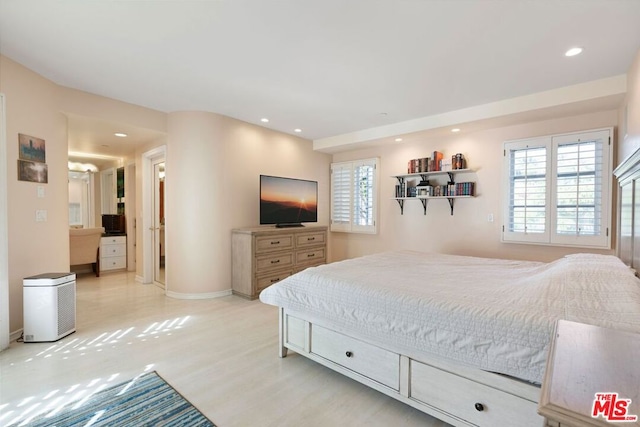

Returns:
27,371,215,427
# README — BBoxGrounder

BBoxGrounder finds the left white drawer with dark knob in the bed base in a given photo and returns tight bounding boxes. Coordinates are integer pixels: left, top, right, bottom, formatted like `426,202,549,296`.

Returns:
311,325,400,390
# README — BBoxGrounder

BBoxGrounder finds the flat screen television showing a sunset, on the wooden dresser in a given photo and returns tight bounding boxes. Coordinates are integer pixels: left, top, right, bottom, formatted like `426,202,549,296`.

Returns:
260,175,318,227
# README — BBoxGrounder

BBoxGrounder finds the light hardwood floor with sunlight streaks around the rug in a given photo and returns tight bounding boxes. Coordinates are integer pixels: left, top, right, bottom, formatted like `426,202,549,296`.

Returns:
0,273,448,427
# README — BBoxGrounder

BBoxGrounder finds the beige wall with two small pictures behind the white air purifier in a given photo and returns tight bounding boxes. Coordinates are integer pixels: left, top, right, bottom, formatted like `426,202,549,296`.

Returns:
0,56,69,331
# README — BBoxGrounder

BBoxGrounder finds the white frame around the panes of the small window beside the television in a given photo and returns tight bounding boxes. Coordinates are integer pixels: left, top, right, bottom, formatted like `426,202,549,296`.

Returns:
330,157,380,234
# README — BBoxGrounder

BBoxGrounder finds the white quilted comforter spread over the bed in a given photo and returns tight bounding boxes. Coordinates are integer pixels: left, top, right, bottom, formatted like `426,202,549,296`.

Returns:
260,251,640,383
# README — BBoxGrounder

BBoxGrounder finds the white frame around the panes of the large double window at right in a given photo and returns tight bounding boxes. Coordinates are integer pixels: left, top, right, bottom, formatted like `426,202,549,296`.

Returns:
501,128,613,249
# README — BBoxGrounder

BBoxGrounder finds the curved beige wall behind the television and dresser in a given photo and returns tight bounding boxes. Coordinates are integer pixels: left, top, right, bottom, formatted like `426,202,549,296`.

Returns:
166,112,331,298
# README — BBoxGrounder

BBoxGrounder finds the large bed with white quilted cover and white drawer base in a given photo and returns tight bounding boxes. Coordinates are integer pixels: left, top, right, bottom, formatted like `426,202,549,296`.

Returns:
260,251,640,427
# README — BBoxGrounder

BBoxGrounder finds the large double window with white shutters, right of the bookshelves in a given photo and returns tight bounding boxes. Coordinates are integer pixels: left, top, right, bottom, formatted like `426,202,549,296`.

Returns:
502,129,613,248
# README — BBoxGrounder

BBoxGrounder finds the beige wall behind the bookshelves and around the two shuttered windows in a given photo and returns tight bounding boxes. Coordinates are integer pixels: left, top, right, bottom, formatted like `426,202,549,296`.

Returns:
331,110,618,261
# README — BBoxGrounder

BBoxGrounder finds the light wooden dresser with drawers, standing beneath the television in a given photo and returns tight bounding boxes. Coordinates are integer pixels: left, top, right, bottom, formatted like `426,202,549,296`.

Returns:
231,226,327,299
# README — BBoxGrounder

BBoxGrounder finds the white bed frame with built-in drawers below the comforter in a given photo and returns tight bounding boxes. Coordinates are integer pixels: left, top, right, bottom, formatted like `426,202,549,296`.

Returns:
279,307,544,427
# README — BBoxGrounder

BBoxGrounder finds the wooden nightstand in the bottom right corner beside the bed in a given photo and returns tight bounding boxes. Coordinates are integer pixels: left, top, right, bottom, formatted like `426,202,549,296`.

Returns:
538,320,640,427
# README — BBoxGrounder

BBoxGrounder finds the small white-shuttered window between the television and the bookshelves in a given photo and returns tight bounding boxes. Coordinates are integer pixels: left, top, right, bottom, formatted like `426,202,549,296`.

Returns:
331,158,378,233
